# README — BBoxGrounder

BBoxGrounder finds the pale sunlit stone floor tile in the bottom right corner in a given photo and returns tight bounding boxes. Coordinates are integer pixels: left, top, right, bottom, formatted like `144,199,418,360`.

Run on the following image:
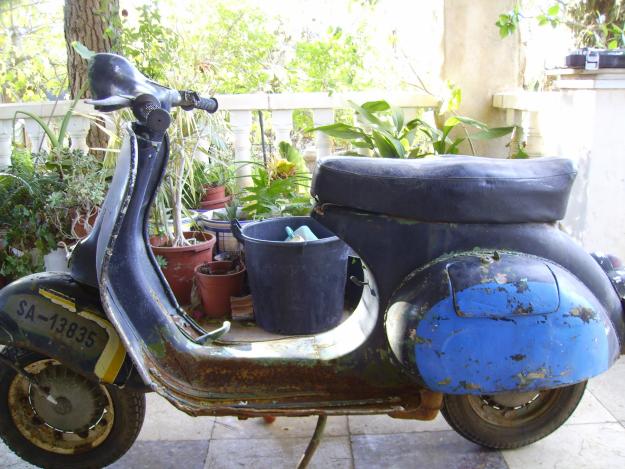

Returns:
502,423,625,469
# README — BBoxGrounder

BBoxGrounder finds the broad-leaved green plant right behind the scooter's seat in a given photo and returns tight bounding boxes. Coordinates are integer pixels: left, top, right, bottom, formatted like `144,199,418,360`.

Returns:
310,101,514,158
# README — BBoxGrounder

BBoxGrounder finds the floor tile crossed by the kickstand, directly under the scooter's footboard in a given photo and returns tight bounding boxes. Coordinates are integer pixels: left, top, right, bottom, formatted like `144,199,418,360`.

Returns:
212,416,349,440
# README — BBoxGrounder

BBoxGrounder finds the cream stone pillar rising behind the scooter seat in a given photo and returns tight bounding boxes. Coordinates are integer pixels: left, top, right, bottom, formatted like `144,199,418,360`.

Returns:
443,0,522,157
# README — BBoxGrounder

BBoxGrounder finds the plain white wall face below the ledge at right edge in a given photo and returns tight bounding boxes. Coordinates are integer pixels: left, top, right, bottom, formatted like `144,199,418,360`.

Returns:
541,82,625,259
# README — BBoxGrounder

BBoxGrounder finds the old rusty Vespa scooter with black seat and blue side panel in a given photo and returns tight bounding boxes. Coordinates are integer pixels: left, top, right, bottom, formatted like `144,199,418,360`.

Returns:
0,54,625,468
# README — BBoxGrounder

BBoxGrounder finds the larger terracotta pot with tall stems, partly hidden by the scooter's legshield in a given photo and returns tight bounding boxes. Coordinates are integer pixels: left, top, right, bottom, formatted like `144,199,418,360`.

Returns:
150,231,216,305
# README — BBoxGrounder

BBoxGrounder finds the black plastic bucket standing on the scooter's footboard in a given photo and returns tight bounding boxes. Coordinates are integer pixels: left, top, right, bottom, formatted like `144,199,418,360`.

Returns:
232,217,348,335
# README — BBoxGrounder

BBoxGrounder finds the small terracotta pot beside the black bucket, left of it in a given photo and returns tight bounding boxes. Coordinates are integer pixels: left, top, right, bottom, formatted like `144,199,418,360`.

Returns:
195,261,245,318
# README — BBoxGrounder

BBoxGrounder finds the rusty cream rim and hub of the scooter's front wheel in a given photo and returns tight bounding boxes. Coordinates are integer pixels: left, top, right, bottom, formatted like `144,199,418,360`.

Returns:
8,360,115,454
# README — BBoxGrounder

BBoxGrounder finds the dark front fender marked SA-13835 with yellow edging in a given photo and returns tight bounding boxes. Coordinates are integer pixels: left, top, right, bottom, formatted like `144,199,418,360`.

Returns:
0,272,136,386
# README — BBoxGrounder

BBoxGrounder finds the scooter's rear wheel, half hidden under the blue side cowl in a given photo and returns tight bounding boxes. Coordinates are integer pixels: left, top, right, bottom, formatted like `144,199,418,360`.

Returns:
441,381,586,449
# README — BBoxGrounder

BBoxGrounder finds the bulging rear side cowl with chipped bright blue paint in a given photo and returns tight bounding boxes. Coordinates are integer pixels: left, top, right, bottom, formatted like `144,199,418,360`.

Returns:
385,251,620,394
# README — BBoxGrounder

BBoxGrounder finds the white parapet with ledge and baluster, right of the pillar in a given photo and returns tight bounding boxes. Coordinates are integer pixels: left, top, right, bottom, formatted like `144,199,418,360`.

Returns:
493,69,625,258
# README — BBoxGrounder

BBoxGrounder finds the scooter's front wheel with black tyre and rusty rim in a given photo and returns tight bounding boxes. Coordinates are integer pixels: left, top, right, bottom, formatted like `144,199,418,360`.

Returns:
0,349,145,469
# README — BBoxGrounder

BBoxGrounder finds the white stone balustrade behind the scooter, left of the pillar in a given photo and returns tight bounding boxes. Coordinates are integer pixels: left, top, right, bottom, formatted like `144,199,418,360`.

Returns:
0,91,439,171
